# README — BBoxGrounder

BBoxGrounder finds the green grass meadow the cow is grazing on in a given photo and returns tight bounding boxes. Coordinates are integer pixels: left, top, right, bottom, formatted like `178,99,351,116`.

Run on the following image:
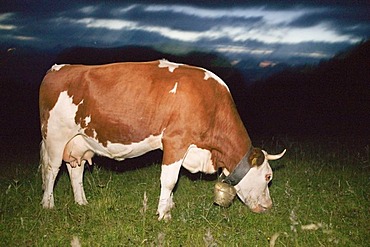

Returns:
0,139,370,246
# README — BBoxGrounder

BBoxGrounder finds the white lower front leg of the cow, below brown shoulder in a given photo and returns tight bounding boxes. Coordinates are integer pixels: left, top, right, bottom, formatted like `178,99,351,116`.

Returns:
157,160,182,221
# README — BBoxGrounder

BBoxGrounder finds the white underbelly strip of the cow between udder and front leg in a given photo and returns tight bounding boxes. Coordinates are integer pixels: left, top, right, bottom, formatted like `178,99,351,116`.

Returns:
73,134,162,161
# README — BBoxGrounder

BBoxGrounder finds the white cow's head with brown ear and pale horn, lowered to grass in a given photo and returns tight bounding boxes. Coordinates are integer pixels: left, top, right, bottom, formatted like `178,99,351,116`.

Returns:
235,149,286,213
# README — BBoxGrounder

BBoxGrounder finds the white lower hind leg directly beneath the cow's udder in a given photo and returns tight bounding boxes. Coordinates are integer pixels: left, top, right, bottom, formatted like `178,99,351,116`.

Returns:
66,161,87,205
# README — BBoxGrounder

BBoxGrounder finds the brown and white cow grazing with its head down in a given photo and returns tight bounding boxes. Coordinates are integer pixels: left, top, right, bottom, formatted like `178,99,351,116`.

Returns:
39,59,285,220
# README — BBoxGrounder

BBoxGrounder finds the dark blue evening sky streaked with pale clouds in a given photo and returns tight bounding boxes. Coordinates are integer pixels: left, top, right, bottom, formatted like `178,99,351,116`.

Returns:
0,0,370,63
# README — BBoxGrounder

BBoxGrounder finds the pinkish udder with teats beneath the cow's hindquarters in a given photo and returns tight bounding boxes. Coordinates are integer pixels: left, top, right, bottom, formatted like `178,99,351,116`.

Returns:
63,135,94,167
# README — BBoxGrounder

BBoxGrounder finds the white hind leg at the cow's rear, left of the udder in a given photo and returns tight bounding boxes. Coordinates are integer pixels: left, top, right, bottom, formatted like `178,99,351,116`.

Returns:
40,141,63,208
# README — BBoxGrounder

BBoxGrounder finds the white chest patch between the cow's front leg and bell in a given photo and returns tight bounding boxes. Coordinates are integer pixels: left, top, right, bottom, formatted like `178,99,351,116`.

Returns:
182,144,216,174
